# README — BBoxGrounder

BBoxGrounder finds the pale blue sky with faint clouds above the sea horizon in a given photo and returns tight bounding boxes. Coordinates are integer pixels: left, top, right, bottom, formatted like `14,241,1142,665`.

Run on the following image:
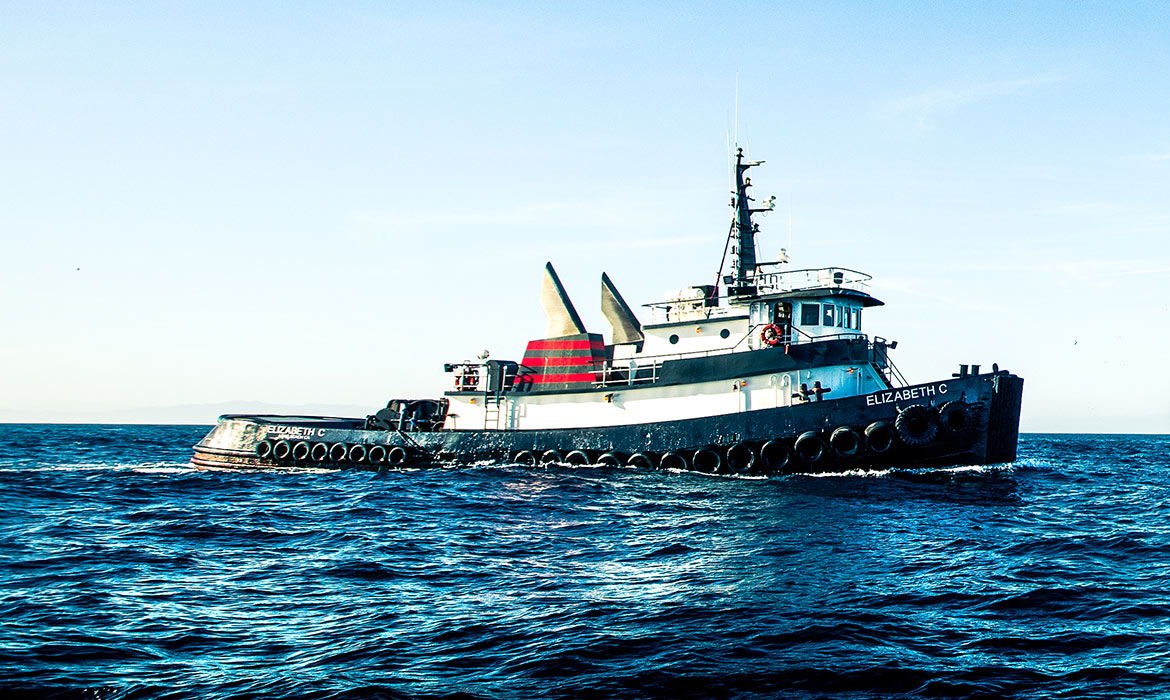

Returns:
0,0,1170,433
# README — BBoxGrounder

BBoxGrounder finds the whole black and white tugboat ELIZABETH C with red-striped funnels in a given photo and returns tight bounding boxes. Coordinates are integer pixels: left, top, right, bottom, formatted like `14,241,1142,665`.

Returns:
192,149,1024,474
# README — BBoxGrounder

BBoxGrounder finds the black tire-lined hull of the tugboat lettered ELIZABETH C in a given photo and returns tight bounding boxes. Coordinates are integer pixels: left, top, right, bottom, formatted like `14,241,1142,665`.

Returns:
192,372,1024,473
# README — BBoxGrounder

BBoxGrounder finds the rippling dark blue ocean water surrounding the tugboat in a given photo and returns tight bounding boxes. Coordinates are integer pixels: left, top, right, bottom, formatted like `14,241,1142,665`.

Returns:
0,425,1170,699
